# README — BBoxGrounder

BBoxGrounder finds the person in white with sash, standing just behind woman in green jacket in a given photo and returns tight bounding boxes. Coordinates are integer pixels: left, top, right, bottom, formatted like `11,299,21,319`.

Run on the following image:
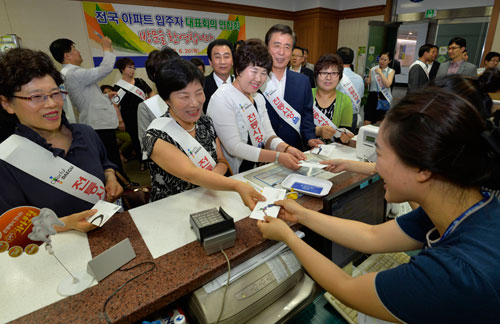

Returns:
336,47,365,133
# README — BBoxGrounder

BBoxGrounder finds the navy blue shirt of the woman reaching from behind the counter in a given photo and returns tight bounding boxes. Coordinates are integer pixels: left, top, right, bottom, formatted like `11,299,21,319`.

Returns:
375,198,500,324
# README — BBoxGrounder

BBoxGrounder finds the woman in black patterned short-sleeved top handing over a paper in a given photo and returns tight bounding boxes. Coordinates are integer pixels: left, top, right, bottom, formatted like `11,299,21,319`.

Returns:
143,58,264,209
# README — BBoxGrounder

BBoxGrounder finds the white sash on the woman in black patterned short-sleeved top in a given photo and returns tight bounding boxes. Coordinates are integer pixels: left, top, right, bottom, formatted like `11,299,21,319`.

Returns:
148,117,216,170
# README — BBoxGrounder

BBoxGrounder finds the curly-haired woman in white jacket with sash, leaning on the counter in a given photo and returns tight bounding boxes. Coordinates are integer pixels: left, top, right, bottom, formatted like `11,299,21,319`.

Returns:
207,39,305,173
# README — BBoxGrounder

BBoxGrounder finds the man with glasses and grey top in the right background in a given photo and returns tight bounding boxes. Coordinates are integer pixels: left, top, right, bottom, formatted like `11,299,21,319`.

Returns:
436,37,477,78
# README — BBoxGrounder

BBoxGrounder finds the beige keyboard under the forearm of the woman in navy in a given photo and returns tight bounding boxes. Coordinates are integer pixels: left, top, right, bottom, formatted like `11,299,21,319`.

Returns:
324,252,410,324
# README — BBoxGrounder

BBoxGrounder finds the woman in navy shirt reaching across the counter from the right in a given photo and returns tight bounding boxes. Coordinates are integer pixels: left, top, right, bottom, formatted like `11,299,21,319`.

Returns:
258,87,500,323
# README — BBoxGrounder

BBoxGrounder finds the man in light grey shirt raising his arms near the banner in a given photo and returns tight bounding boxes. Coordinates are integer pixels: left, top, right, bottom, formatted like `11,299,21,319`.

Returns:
50,37,126,176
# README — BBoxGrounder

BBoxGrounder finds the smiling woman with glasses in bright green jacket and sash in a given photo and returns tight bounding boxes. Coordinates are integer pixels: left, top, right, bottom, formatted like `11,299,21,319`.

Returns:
313,54,353,143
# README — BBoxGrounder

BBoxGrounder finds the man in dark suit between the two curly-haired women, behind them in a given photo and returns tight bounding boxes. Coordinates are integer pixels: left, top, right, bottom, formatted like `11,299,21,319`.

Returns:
203,39,233,113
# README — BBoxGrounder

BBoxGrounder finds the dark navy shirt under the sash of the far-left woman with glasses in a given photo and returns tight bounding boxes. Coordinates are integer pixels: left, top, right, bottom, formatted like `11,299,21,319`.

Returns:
0,117,116,217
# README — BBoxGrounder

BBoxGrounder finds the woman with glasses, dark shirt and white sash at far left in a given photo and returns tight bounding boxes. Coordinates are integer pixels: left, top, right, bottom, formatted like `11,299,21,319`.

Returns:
0,49,123,232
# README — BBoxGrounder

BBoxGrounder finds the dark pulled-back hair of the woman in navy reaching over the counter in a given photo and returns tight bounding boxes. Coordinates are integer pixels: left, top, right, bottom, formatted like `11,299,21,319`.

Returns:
383,86,495,188
